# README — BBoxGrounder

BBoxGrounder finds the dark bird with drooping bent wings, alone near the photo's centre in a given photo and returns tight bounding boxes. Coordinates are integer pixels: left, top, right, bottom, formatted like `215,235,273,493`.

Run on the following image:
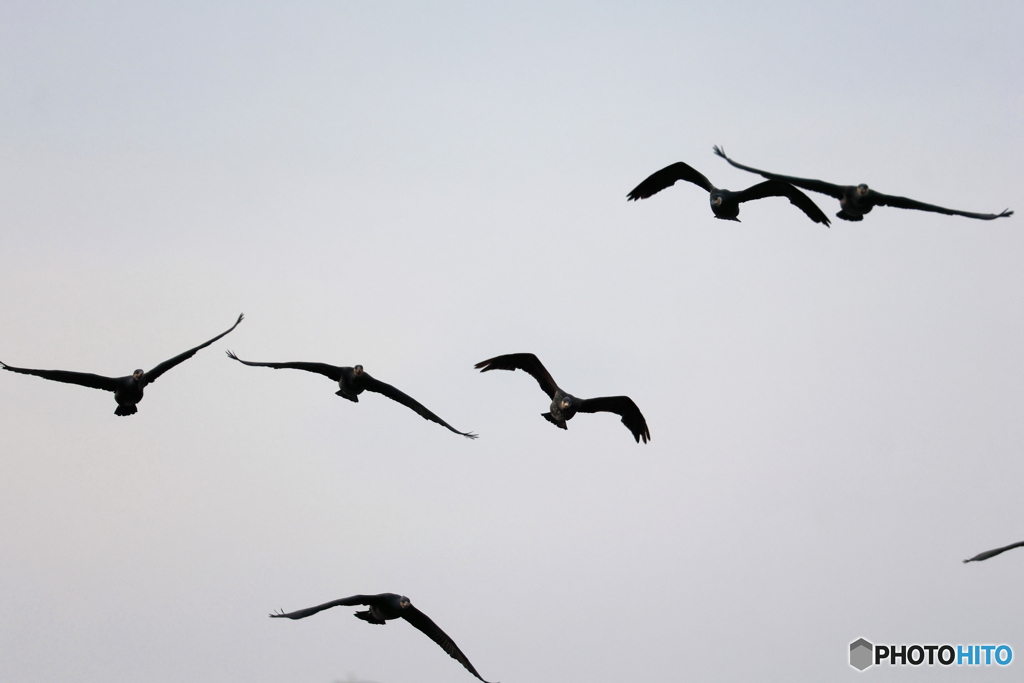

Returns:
473,353,650,443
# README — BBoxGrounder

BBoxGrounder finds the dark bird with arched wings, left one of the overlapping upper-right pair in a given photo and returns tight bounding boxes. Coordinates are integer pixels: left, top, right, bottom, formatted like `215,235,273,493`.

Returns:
626,157,829,227
